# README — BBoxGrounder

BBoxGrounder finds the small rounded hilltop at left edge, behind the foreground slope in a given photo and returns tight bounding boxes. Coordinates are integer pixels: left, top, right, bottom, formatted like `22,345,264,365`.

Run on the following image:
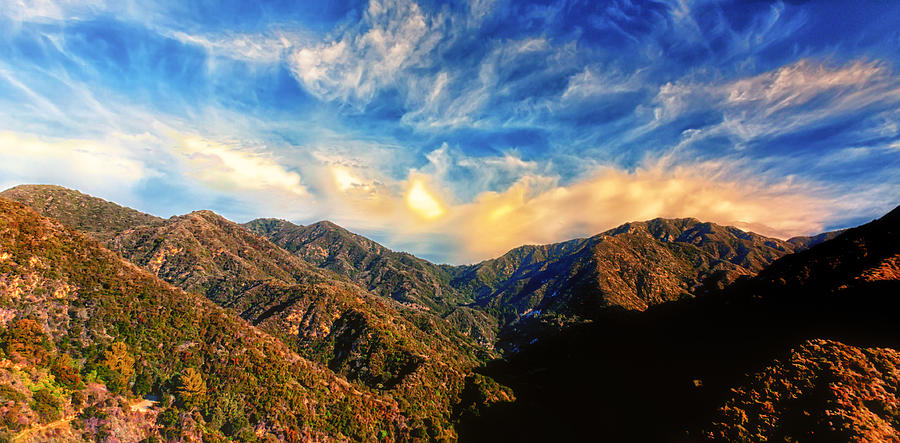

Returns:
0,185,162,240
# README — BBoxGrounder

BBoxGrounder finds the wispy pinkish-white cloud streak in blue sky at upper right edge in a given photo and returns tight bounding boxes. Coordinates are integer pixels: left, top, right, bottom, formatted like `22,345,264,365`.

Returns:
650,59,900,141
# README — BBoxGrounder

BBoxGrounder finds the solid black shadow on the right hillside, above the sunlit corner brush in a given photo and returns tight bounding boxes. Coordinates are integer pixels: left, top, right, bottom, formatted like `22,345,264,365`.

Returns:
459,281,900,441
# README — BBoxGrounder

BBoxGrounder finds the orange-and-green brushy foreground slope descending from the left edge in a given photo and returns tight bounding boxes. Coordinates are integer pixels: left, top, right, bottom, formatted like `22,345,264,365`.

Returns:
0,199,408,440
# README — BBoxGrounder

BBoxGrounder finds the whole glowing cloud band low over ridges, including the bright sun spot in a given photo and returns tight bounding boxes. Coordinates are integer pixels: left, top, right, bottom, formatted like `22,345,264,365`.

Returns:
294,146,844,263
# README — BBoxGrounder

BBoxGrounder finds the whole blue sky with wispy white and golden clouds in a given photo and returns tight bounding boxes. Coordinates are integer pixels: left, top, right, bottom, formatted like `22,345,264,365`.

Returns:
0,0,900,263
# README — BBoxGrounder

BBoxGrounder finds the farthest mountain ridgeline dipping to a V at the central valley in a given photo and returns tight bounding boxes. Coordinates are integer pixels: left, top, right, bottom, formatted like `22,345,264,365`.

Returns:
245,219,824,352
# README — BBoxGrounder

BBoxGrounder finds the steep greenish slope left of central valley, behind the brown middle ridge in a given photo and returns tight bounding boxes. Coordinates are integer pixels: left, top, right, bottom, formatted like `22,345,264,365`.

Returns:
244,219,498,347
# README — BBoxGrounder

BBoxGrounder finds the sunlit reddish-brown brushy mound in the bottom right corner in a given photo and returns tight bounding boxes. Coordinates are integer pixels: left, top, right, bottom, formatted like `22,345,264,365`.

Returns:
705,340,900,442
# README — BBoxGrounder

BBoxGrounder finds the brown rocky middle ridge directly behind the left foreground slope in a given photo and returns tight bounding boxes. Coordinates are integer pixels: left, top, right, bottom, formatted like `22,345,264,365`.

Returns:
109,211,502,438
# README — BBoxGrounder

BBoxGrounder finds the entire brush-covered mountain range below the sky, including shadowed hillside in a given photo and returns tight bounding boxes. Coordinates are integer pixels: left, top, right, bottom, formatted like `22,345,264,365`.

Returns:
0,185,900,441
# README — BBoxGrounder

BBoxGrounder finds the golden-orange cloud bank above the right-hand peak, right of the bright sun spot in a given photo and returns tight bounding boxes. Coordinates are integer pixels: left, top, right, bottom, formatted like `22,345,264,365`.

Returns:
447,163,836,261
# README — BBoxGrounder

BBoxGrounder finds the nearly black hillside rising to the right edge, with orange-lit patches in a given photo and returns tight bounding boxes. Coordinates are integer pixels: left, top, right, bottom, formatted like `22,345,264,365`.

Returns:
460,206,900,441
